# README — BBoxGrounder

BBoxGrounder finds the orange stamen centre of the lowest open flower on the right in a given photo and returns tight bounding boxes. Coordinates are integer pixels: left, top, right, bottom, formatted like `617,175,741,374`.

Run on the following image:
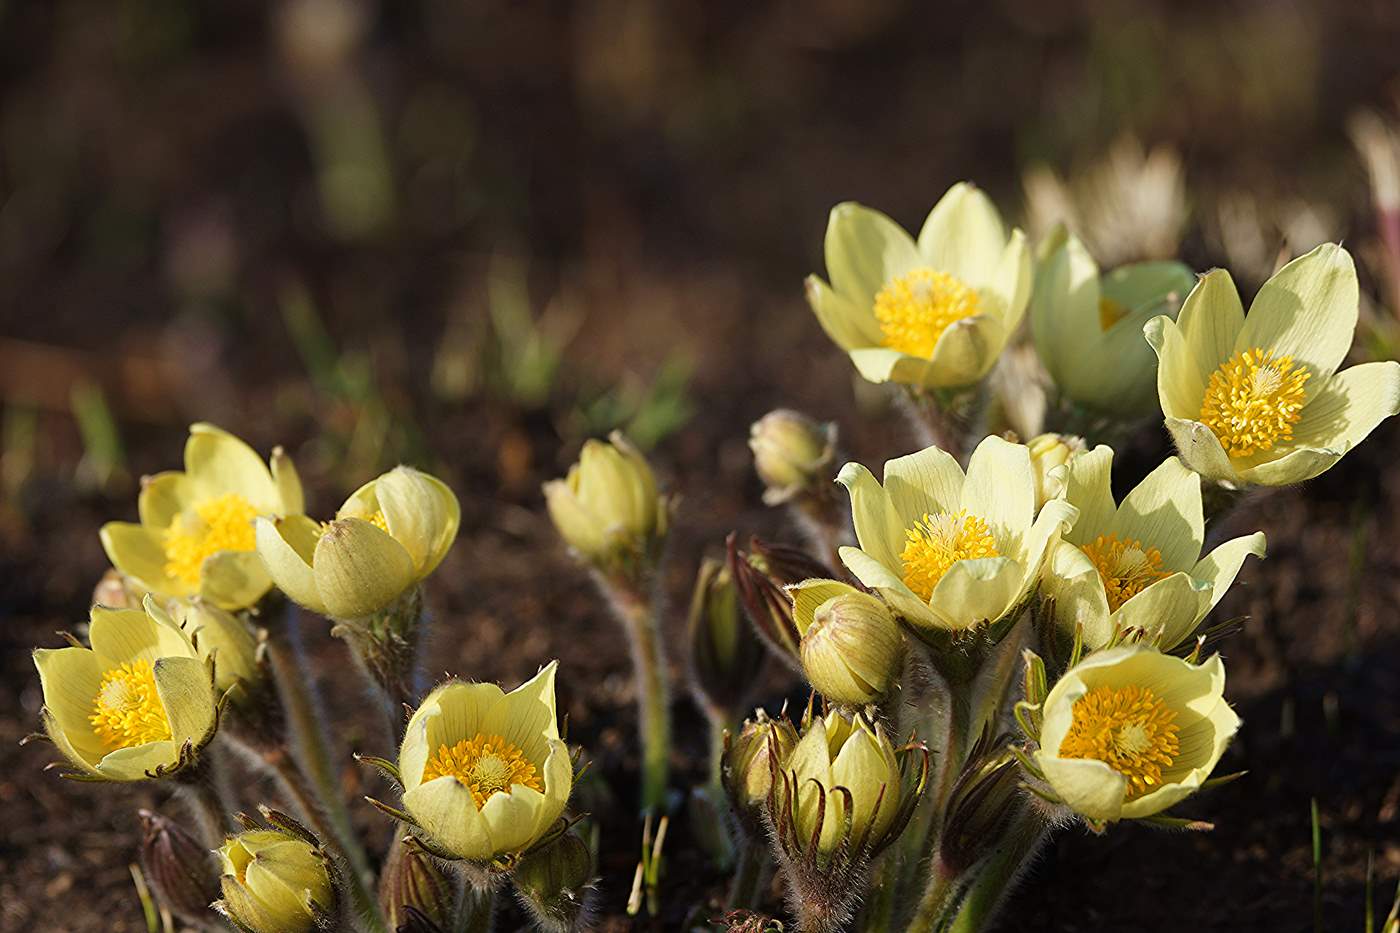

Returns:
1060,685,1182,800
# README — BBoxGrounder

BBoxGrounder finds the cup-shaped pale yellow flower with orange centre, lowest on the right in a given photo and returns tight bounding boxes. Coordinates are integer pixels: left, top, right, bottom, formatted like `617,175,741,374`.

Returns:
1035,646,1239,821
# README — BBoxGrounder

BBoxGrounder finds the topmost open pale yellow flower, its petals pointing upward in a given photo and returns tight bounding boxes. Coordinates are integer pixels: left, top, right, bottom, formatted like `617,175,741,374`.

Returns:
806,182,1030,388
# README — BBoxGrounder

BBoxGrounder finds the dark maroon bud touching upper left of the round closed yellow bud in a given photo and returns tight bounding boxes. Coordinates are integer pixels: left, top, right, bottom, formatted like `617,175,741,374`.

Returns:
725,534,833,672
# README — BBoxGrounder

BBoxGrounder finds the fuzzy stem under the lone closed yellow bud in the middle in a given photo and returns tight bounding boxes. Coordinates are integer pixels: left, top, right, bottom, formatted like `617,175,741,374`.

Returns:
595,574,671,813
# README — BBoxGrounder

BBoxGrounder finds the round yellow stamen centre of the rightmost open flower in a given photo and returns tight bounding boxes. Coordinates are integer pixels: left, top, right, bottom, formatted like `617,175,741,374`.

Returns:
1201,347,1312,457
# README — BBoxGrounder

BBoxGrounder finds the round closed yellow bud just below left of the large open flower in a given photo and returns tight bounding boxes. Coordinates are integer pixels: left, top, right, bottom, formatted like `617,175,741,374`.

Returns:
788,580,904,706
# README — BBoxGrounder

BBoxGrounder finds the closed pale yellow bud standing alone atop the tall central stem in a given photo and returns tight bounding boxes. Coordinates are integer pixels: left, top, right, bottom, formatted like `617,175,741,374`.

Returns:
545,431,669,569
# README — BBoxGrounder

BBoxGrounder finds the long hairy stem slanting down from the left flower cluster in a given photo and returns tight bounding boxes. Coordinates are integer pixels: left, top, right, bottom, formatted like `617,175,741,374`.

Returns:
267,604,382,929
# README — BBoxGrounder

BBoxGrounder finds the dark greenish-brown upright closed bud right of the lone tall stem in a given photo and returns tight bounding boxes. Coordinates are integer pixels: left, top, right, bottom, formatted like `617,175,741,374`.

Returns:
687,559,764,724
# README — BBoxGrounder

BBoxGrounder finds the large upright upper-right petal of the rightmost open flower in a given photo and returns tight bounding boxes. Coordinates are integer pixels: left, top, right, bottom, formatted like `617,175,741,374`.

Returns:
1233,242,1359,389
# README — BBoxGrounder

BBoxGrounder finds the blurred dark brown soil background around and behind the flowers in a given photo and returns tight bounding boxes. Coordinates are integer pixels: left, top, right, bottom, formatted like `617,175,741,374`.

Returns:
0,0,1400,932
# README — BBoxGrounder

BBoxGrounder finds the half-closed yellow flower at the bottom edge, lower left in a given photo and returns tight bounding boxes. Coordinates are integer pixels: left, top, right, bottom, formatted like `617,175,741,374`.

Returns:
216,829,336,933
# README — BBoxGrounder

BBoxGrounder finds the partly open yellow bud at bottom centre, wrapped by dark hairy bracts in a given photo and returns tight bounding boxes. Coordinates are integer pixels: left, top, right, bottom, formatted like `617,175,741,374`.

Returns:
781,712,904,856
